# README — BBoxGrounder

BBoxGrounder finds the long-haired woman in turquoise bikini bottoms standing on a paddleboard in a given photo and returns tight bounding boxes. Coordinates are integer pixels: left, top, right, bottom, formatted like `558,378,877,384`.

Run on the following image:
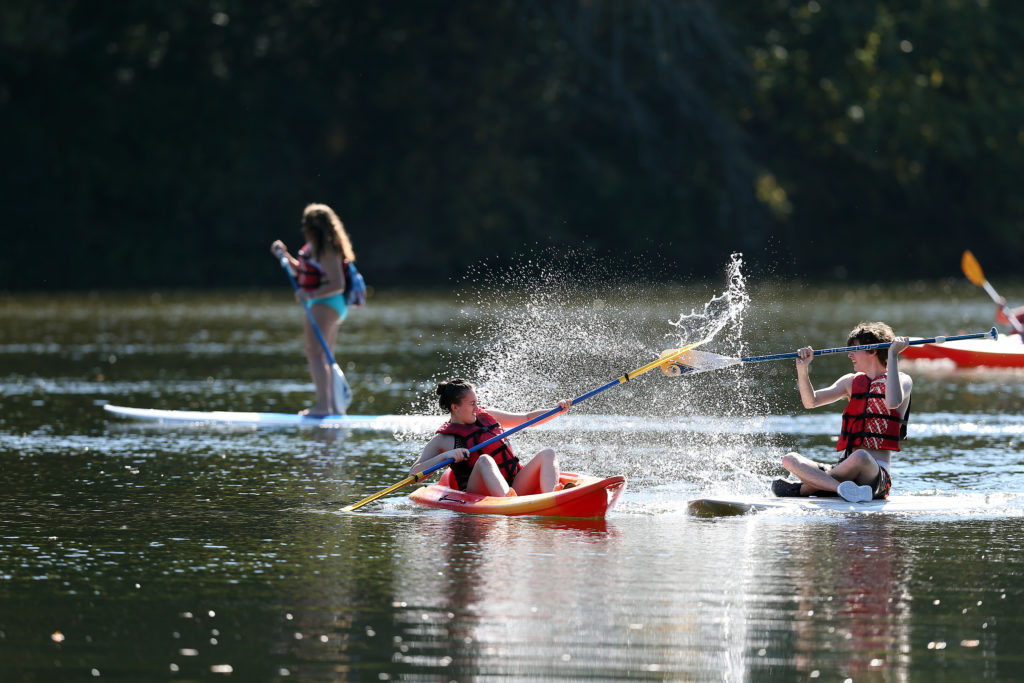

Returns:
270,204,355,417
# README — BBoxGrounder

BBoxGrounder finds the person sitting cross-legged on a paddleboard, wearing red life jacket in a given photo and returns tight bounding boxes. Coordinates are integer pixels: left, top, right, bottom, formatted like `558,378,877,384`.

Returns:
771,323,913,503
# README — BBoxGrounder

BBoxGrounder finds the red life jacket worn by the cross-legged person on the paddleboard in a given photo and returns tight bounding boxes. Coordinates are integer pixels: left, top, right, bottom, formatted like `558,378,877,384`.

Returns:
836,373,910,456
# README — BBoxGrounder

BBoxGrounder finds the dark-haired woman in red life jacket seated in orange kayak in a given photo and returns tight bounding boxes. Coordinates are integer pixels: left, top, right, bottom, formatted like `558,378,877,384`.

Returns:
409,378,572,497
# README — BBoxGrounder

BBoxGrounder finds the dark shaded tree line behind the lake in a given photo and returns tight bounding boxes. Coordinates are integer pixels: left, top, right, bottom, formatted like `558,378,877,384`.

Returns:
0,0,1024,290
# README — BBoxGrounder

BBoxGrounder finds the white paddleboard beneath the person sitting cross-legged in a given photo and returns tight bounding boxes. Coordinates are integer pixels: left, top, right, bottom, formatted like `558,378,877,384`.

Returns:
687,494,1019,517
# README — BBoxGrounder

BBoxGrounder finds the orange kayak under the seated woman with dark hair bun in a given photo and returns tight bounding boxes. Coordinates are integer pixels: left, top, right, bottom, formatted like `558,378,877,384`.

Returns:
410,469,626,518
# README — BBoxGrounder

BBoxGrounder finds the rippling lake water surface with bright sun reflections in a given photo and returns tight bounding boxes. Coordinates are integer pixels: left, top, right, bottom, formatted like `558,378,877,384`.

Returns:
0,283,1024,681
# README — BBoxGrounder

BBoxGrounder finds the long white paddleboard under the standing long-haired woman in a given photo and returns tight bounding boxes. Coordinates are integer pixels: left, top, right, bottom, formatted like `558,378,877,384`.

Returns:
103,404,425,431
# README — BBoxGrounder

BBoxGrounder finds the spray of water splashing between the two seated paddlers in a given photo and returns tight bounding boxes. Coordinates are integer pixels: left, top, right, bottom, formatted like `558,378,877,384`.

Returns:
403,252,778,495
